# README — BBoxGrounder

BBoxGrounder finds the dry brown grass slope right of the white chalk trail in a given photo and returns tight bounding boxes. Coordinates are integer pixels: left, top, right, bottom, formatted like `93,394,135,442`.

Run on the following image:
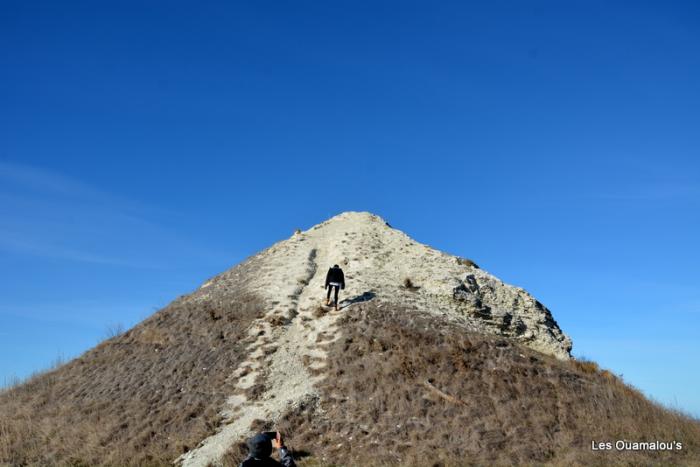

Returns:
226,303,700,466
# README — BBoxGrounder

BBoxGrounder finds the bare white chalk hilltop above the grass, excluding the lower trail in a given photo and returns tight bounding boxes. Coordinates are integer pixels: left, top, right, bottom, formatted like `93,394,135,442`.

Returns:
201,212,572,359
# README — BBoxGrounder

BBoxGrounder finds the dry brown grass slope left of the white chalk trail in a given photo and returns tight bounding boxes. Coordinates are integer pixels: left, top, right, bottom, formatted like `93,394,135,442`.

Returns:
0,260,264,466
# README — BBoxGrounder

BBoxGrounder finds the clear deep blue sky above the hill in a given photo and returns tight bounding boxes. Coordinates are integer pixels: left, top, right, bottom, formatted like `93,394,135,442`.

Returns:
0,1,700,415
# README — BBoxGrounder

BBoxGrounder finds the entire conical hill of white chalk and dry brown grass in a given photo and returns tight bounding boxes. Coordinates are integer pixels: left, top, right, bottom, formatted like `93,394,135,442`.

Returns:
0,213,700,466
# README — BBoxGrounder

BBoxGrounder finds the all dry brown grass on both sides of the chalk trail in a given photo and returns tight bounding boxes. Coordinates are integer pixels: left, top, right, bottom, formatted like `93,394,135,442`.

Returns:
0,282,700,466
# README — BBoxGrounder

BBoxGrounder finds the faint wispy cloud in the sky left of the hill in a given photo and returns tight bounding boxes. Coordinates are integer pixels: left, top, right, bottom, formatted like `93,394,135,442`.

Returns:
0,162,220,268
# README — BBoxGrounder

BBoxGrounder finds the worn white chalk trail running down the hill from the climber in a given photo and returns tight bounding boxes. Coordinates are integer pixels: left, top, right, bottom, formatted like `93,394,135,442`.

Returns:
177,233,342,467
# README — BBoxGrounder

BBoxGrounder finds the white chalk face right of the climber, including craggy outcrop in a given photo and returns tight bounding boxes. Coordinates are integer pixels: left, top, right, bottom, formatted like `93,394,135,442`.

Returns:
302,212,571,359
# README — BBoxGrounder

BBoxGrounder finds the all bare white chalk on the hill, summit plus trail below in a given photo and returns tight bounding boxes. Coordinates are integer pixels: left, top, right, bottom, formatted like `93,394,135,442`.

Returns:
178,212,571,466
